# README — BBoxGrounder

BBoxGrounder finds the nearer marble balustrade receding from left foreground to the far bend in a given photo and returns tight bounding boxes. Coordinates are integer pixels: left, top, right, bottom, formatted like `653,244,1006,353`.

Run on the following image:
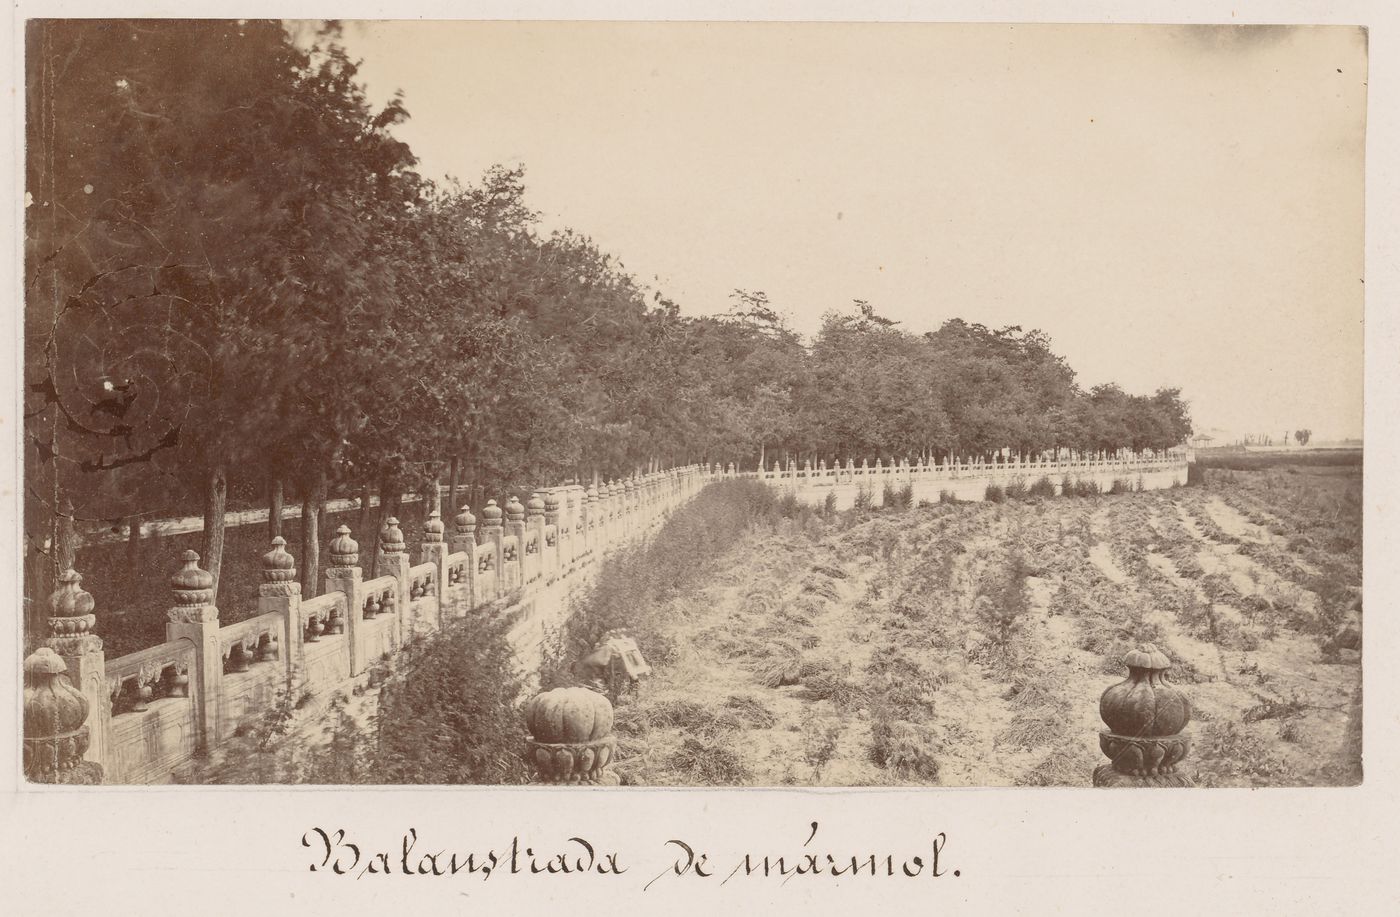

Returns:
38,465,717,784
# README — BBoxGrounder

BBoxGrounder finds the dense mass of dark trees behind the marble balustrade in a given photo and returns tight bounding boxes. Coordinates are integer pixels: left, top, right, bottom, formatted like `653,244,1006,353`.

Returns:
25,20,1190,624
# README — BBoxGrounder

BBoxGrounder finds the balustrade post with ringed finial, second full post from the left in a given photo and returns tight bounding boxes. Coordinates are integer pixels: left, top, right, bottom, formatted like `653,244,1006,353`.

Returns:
165,550,224,753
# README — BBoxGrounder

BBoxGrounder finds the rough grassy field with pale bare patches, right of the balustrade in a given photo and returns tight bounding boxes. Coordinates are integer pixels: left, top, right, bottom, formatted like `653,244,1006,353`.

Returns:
588,468,1361,787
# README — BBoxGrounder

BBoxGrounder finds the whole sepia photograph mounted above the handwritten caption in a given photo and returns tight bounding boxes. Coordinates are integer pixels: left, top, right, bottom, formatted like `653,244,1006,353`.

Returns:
15,18,1369,789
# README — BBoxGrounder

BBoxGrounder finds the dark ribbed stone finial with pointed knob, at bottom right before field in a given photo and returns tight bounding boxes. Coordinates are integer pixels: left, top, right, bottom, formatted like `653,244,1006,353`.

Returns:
1093,644,1191,787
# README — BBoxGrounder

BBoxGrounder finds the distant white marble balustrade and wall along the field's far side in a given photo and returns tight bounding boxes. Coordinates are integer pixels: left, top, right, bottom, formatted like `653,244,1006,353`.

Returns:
722,449,1193,510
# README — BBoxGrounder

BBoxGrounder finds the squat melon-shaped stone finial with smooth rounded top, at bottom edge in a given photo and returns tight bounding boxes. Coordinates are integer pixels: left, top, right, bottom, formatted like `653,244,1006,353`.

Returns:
525,687,617,784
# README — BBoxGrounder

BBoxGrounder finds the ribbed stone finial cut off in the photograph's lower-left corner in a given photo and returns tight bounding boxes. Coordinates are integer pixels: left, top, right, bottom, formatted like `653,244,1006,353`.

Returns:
22,649,102,785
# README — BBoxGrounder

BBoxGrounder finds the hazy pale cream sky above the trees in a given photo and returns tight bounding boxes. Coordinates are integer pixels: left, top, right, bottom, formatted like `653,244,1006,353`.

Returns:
346,21,1366,440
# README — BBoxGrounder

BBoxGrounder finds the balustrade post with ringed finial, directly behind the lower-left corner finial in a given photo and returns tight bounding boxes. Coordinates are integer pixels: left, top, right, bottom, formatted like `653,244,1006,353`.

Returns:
45,568,112,764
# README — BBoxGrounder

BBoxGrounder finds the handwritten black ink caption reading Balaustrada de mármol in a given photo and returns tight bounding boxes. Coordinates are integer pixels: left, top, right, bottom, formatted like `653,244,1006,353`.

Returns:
301,822,962,890
